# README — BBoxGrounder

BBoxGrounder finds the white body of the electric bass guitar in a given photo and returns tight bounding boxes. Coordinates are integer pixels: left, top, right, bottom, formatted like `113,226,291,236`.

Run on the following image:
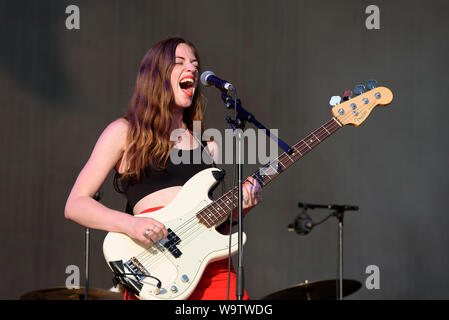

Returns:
103,168,246,300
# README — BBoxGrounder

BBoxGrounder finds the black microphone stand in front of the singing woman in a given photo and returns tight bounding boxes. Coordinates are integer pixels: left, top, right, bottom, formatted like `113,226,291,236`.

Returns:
221,89,292,300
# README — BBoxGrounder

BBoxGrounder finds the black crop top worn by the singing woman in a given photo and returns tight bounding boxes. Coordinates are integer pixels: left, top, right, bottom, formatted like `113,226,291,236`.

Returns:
114,142,214,214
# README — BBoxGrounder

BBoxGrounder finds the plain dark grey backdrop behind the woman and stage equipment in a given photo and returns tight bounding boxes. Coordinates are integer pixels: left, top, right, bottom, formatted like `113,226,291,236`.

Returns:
0,0,449,299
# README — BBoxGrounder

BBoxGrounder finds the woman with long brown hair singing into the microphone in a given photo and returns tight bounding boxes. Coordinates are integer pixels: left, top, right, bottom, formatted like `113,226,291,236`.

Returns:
65,38,261,300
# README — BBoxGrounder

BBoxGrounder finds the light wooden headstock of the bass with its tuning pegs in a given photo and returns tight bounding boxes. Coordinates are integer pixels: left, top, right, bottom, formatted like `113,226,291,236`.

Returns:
331,80,393,127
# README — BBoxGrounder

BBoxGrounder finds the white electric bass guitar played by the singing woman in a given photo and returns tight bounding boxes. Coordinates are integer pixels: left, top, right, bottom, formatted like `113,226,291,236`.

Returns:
103,87,393,300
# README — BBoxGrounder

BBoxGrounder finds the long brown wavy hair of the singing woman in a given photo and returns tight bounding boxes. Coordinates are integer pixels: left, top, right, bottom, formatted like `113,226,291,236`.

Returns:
120,38,205,180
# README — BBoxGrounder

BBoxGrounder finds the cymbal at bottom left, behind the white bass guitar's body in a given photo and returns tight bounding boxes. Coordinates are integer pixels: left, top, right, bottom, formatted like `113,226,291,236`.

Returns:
20,287,123,300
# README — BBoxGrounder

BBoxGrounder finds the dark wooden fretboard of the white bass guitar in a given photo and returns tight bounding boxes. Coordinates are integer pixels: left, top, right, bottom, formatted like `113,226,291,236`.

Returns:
197,118,341,228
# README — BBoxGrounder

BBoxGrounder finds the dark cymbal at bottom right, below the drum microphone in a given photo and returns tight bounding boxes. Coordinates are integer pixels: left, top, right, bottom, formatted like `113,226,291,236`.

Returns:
262,279,362,300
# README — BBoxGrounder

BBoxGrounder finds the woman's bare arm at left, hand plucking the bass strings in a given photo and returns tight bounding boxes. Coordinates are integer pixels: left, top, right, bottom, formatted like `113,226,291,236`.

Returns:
64,119,167,243
